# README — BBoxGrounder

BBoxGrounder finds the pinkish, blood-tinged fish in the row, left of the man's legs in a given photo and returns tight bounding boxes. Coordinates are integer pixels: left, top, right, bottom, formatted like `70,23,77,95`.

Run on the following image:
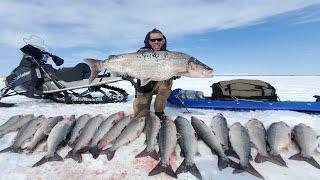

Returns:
98,116,133,151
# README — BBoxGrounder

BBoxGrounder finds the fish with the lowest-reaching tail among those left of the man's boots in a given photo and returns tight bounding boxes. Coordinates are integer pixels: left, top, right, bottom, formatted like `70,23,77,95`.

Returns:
32,116,75,167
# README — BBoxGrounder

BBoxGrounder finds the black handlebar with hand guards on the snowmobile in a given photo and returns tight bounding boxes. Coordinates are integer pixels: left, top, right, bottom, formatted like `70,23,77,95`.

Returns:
20,44,64,66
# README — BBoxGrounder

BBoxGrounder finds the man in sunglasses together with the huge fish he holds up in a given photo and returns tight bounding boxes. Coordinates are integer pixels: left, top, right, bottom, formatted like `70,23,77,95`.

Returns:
85,29,213,120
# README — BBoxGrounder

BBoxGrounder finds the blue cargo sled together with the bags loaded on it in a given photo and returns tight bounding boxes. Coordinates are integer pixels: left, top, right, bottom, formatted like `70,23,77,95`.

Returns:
168,79,320,112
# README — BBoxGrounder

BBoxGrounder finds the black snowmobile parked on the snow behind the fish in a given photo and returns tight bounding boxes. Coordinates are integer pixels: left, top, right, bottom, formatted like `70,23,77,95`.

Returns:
0,36,128,107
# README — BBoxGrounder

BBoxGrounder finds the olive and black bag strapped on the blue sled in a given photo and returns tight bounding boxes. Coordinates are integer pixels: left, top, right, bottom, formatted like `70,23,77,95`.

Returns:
210,79,278,101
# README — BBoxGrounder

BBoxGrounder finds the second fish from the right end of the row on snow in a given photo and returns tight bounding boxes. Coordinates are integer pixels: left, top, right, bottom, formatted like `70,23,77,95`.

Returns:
267,121,292,166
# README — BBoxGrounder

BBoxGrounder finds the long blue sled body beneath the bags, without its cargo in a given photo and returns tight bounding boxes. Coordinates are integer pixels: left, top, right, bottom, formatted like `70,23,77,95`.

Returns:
168,89,320,112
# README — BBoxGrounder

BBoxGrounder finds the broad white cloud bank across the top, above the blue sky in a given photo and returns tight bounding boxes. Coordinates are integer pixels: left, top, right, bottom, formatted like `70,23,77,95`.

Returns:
0,0,320,48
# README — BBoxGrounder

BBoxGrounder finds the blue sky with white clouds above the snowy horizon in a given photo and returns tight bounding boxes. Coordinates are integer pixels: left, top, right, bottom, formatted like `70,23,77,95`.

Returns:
0,0,320,75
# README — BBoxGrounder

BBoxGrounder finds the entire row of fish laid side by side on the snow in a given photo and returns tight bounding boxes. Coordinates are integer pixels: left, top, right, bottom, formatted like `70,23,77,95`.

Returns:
0,111,320,179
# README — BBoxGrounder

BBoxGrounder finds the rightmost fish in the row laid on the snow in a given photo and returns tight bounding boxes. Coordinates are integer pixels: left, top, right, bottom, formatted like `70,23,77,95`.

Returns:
289,123,320,169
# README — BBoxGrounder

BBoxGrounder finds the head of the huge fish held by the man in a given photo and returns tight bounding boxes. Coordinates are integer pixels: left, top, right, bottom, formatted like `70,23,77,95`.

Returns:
184,57,213,78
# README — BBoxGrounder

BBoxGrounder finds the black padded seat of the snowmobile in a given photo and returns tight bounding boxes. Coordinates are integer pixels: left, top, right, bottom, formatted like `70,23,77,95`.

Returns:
54,63,91,82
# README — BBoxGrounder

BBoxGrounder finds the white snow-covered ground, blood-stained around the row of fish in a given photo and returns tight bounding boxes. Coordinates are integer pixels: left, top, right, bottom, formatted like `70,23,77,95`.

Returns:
0,76,320,180
